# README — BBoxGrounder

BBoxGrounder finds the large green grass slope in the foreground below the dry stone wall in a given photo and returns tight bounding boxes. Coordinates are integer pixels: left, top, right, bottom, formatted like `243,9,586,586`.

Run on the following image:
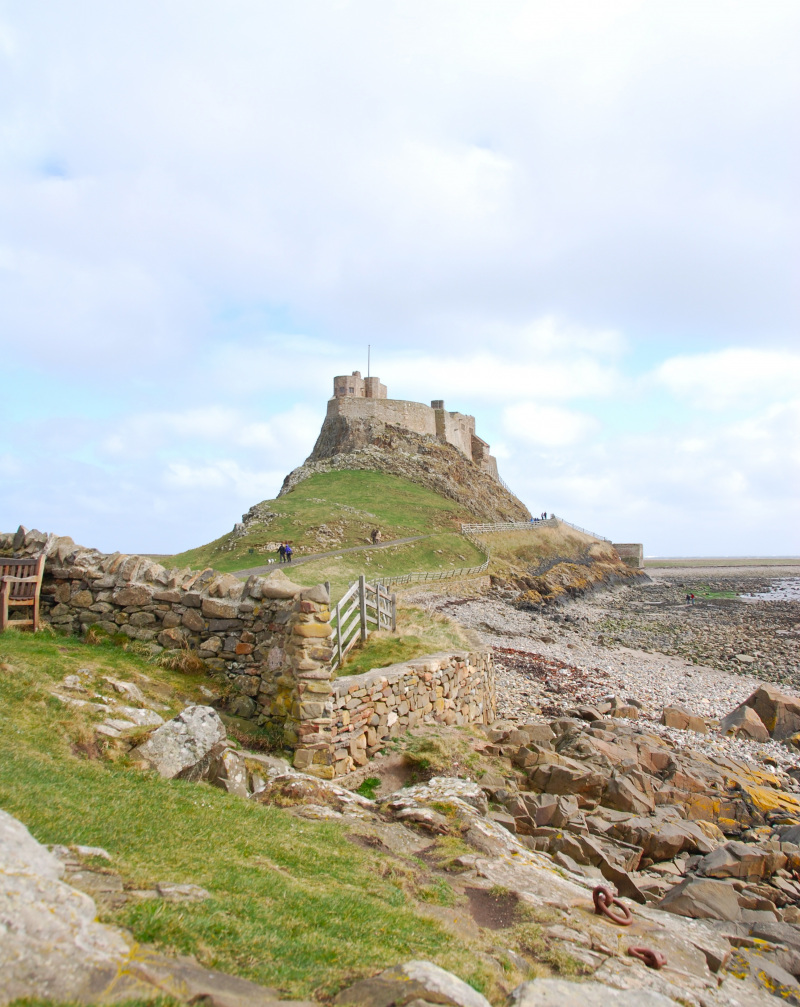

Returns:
0,631,485,997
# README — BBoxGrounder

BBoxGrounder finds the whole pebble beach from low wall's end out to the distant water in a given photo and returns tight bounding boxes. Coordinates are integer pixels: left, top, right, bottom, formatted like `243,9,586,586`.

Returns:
404,567,800,768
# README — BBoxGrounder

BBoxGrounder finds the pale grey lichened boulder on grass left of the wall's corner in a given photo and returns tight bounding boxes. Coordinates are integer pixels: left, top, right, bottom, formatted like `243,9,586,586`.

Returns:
131,706,228,779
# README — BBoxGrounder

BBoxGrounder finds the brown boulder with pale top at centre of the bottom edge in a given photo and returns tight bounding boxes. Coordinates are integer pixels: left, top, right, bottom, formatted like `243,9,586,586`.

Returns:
334,962,491,1007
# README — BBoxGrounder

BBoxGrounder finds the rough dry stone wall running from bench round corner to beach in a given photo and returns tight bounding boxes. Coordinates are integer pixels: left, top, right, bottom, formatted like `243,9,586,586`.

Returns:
0,528,495,778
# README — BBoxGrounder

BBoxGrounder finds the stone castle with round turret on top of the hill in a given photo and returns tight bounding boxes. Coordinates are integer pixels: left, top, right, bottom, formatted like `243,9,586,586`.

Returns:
326,371,499,479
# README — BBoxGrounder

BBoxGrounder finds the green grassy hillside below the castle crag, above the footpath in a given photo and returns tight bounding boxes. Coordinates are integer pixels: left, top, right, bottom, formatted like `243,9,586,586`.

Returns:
160,469,474,572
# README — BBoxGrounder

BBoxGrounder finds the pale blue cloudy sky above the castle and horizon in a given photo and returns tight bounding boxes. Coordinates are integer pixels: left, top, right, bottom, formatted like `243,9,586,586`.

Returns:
0,0,800,556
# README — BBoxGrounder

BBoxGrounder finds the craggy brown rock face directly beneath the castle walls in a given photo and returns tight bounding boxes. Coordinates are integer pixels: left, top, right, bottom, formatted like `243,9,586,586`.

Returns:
278,417,531,521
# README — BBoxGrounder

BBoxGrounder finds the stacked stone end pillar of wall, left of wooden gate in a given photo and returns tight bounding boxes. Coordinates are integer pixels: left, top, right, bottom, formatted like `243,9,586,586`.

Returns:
284,584,334,779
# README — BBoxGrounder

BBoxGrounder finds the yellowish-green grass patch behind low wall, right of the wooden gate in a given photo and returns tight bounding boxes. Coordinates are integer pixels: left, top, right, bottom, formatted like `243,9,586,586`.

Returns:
337,605,474,676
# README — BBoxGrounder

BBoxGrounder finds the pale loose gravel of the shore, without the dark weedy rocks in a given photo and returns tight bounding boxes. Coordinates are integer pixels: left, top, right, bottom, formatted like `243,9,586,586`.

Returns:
404,570,800,768
